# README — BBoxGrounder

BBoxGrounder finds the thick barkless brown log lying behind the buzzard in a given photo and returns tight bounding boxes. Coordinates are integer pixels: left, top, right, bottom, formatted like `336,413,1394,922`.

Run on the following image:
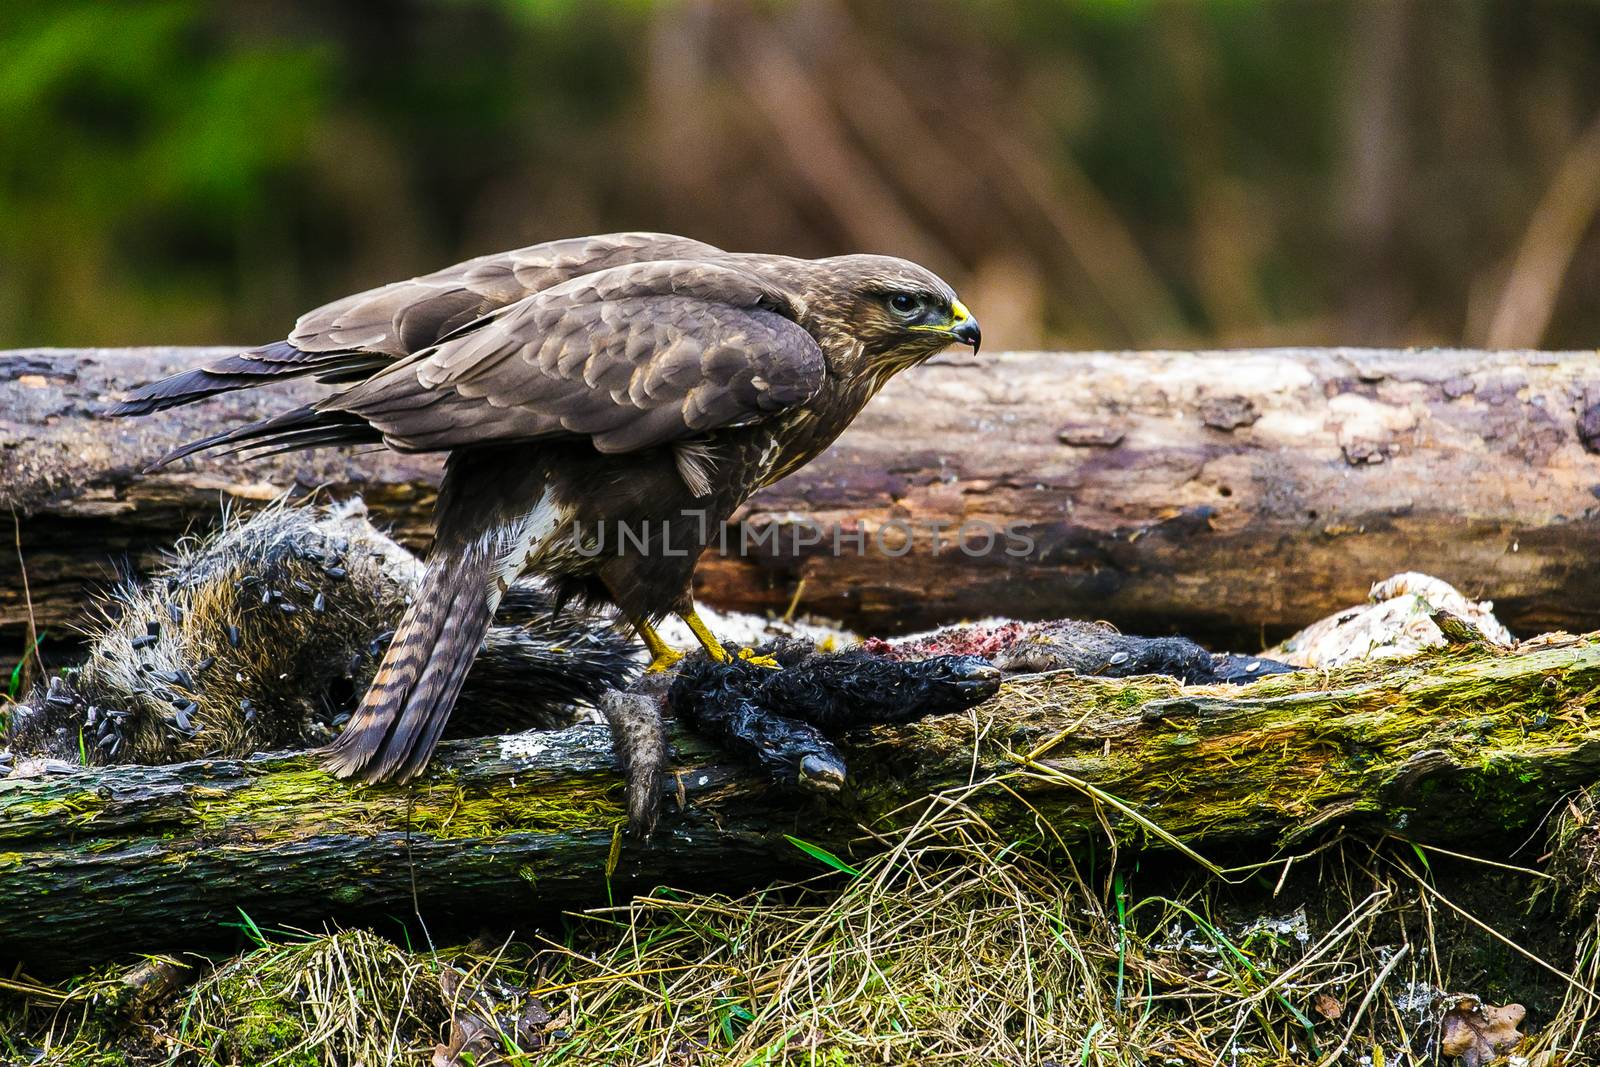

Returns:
0,349,1600,646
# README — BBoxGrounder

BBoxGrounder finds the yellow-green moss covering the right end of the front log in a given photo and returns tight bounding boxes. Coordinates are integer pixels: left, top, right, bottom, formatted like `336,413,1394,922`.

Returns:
960,641,1600,838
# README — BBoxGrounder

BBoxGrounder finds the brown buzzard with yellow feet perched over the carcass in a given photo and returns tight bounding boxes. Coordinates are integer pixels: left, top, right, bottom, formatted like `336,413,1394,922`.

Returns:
114,234,981,781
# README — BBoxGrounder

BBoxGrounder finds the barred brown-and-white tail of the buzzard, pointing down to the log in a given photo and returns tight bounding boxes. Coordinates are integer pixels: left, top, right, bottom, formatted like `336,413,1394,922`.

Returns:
323,545,493,782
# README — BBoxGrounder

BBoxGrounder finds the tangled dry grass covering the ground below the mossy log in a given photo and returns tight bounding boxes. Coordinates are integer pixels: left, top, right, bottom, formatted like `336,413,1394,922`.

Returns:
9,780,1600,1067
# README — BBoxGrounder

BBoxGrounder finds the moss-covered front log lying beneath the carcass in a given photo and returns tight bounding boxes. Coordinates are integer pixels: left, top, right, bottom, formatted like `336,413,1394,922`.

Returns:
0,635,1600,969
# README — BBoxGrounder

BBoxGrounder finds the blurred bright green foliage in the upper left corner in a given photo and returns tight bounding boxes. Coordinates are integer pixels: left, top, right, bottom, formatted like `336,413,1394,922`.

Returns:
0,0,328,341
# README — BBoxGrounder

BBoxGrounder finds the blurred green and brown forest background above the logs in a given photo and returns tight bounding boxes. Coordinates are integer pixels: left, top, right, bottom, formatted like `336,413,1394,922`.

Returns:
0,0,1600,355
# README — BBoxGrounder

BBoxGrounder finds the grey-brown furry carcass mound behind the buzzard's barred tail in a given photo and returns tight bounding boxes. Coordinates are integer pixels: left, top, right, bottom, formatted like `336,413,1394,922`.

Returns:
0,501,632,765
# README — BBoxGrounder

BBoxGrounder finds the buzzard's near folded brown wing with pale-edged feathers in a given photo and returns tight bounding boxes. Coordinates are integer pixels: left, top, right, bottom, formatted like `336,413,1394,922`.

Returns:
318,261,826,451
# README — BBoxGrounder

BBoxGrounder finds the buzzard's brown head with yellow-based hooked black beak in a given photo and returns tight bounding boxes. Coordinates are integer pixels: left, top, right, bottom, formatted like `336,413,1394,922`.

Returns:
805,256,982,376
